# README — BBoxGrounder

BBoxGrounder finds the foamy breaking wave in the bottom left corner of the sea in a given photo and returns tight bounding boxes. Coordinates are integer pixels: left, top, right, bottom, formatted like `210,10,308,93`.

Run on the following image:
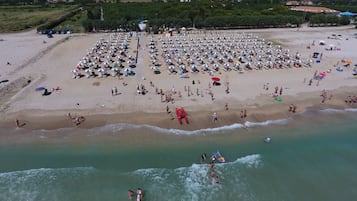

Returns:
0,167,95,201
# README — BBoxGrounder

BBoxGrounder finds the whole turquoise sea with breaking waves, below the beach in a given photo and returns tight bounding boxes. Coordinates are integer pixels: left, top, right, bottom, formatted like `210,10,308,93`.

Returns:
0,109,357,201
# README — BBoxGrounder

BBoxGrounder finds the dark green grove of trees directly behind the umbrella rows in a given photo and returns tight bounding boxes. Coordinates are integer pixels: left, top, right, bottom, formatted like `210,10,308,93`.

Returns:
84,0,303,32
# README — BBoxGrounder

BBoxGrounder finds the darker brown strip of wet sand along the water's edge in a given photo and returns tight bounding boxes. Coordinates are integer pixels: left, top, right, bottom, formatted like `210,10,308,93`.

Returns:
0,87,357,131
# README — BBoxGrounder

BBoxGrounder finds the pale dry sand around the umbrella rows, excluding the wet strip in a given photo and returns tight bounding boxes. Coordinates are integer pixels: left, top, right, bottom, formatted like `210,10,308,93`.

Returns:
0,26,357,125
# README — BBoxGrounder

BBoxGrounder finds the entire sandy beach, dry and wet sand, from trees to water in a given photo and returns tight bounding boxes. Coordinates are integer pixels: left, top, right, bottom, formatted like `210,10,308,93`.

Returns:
0,26,357,130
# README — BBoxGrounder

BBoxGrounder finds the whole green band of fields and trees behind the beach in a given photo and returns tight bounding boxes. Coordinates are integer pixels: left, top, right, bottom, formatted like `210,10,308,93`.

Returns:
0,0,357,32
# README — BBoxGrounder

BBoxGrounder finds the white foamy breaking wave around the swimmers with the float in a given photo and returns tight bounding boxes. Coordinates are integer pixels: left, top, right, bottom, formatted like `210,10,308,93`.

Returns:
131,154,261,201
